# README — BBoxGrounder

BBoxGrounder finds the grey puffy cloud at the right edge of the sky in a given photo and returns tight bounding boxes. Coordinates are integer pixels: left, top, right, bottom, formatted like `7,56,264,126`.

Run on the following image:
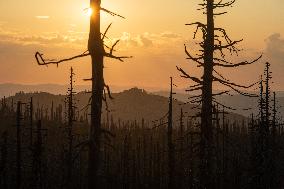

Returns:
265,33,284,62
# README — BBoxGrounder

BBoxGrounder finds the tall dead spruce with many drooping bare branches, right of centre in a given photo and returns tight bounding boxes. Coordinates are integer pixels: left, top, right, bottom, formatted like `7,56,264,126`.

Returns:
177,0,262,188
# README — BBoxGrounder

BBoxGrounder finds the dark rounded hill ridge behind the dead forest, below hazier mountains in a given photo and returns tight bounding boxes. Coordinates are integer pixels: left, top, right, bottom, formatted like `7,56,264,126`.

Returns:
2,88,247,124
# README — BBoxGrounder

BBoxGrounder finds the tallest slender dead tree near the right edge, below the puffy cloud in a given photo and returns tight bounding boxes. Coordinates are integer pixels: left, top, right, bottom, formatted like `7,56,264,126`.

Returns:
251,63,275,188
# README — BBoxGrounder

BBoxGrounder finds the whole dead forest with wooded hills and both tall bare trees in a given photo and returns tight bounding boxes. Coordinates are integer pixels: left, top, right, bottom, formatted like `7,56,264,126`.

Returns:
0,0,284,189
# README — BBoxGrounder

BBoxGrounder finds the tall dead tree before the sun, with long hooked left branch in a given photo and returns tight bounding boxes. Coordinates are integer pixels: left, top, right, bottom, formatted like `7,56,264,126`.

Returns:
35,0,130,189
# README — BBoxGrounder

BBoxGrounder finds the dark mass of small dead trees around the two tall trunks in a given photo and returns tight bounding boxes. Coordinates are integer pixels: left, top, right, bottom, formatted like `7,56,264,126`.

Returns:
0,74,284,189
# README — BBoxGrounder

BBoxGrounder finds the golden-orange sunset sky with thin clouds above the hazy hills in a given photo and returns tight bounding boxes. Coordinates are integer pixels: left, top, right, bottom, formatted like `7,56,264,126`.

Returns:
0,0,284,90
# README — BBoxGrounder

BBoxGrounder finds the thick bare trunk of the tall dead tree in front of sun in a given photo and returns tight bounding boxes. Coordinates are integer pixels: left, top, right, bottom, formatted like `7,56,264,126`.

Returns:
88,0,104,189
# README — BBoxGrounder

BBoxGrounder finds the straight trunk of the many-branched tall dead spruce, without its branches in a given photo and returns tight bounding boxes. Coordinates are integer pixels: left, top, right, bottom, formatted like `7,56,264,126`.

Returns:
200,0,214,188
